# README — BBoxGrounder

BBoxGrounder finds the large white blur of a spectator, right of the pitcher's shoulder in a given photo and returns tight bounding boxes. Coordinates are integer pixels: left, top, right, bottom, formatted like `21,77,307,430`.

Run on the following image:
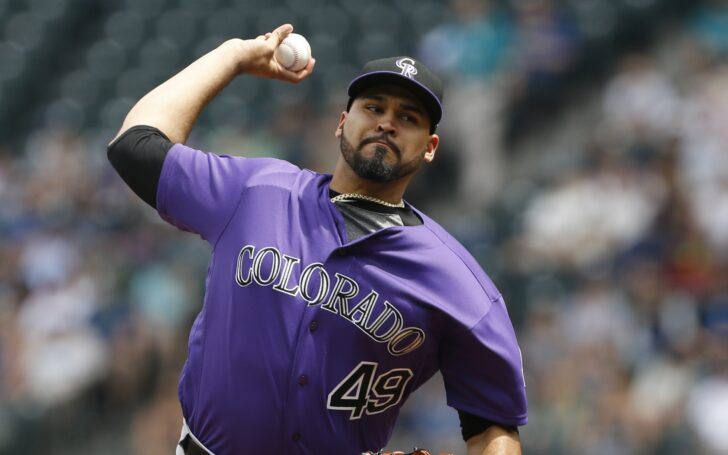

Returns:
524,152,665,267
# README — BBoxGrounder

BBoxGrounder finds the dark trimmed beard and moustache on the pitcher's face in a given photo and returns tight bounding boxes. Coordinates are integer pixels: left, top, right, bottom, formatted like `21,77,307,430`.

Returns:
340,134,426,183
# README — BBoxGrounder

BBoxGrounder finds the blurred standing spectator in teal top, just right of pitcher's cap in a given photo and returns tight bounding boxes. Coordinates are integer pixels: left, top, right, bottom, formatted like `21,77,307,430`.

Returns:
417,0,515,209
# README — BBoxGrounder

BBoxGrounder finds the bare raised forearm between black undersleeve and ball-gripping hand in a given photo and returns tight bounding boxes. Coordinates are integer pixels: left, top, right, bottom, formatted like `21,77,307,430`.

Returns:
111,40,244,143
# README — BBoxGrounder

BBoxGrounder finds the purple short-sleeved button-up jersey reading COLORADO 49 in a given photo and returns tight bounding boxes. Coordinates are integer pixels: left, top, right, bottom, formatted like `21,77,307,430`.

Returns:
157,144,527,455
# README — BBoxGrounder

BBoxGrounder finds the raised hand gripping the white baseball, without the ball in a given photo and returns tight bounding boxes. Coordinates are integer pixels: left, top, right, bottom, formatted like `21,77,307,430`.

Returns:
230,24,316,83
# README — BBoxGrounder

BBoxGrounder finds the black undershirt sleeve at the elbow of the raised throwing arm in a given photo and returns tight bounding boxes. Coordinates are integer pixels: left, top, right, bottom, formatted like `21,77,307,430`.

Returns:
106,125,173,209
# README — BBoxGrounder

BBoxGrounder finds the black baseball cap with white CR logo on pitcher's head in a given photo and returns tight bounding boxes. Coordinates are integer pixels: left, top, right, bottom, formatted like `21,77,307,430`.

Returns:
347,56,442,132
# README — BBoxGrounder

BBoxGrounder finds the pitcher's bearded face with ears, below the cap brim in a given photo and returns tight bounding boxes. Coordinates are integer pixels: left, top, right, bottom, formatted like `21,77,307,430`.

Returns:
336,85,439,183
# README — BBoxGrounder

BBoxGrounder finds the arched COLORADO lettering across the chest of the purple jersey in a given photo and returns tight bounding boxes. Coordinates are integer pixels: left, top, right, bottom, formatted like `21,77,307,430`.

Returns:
235,245,425,356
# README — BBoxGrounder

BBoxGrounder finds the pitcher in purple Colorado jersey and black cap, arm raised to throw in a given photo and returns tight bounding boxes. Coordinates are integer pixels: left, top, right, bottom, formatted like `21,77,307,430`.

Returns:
108,24,527,455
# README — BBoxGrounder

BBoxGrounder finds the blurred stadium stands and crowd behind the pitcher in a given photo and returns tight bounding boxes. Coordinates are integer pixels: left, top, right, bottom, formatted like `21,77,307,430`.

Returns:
0,0,728,455
